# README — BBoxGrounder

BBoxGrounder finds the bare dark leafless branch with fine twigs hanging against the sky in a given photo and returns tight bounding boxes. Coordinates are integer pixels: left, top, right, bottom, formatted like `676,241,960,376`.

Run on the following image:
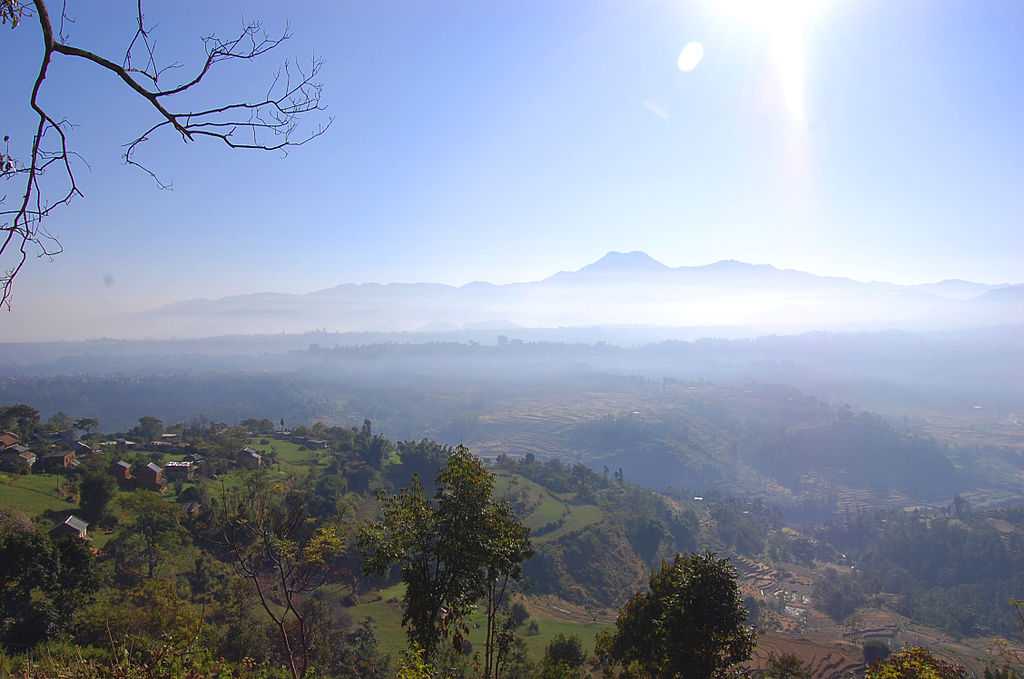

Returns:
0,0,332,309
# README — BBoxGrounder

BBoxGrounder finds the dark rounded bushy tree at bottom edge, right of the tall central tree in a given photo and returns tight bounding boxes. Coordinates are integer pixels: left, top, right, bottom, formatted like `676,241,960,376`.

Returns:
598,553,755,679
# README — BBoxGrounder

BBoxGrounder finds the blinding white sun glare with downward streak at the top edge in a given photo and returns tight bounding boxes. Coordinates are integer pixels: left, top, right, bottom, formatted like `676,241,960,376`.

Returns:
715,0,828,122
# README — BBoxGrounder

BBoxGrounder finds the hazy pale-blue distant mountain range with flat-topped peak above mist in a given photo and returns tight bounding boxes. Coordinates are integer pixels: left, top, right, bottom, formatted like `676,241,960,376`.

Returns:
114,252,1024,337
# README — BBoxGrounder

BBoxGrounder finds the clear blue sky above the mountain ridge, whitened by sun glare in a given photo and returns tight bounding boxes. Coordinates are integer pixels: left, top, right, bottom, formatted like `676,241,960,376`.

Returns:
0,0,1024,326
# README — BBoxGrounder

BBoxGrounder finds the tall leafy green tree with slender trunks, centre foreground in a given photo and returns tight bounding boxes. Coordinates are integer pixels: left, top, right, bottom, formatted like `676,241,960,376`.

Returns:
359,446,531,672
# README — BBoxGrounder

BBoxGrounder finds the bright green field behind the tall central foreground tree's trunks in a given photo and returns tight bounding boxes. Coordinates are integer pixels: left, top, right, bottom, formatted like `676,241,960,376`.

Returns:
348,585,606,659
